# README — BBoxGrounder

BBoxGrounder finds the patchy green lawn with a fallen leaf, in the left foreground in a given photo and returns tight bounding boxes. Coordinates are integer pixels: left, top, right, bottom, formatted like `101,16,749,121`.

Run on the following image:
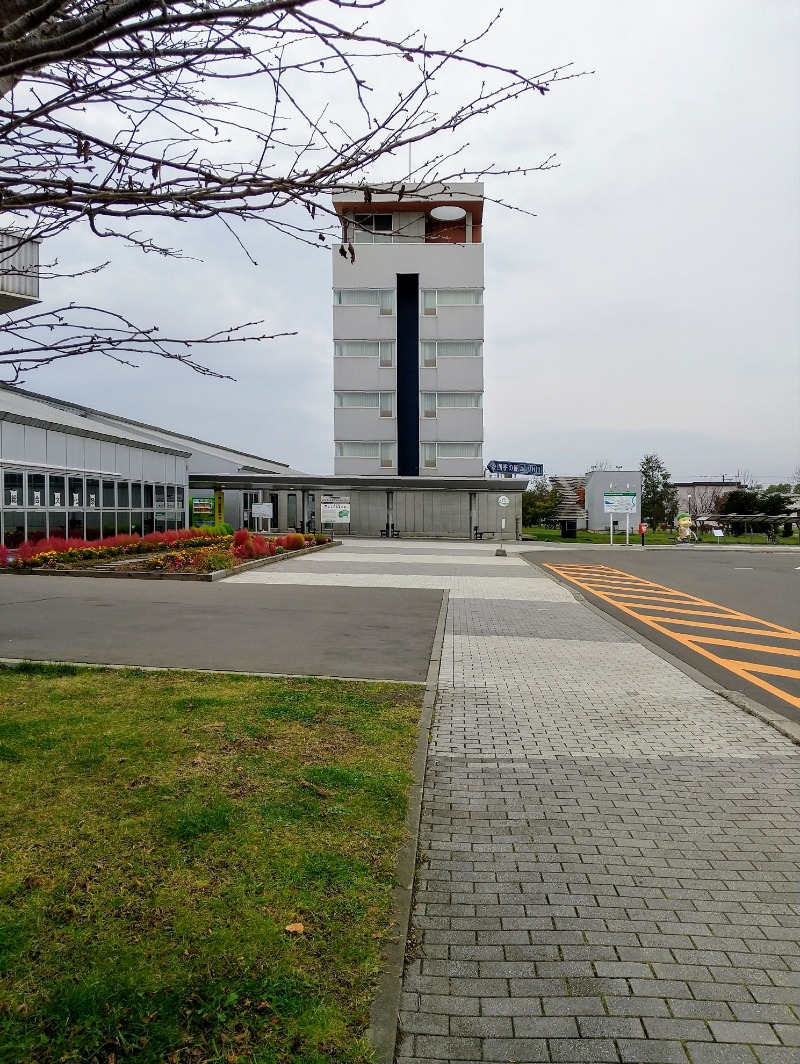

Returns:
0,663,422,1064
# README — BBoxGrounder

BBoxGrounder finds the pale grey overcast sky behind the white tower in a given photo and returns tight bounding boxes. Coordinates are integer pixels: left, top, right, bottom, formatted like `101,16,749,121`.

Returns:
18,0,800,483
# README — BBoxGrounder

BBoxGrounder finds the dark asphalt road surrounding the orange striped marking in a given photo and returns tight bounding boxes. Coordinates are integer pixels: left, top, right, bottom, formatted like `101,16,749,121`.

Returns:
523,547,800,720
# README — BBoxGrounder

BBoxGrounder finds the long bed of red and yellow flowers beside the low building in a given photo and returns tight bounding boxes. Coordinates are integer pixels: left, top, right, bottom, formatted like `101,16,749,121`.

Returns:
0,529,330,575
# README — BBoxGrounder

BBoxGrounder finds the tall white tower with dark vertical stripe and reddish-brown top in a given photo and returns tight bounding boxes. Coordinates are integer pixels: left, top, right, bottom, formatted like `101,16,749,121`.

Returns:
333,183,483,478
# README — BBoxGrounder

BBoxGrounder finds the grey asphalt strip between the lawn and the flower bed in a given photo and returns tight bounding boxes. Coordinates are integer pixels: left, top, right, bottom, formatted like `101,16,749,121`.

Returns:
0,573,443,682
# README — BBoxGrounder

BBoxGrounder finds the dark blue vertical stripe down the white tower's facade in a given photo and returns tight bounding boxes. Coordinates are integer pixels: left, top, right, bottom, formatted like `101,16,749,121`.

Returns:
397,273,419,477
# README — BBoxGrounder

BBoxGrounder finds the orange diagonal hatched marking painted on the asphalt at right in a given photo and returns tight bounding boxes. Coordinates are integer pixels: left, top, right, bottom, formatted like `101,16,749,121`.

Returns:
544,563,800,709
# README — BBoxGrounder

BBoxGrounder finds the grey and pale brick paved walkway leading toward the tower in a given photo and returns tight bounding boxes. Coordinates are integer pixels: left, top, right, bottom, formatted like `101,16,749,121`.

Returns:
227,541,800,1064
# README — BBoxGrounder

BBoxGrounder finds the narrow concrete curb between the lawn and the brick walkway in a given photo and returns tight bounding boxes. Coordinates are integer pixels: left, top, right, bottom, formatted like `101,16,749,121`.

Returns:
367,592,450,1064
